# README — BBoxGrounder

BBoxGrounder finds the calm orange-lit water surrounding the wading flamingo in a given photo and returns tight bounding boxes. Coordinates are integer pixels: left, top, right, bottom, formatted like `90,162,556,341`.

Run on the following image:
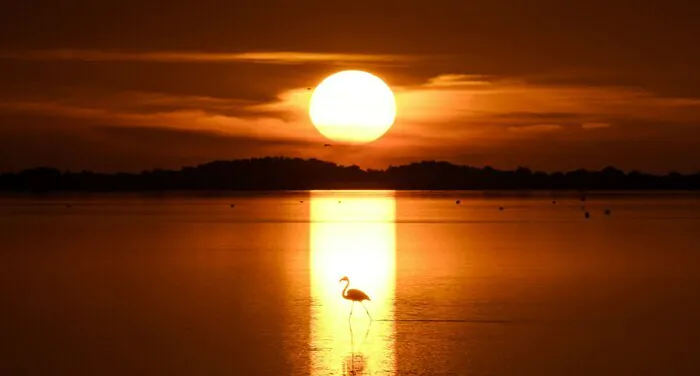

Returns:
0,192,700,375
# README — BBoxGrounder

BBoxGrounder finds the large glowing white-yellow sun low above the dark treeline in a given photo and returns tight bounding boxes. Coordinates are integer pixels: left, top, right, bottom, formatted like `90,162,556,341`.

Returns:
309,70,396,144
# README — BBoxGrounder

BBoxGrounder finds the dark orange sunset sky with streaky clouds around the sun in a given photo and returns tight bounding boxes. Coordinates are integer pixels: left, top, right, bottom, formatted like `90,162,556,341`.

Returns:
0,0,700,173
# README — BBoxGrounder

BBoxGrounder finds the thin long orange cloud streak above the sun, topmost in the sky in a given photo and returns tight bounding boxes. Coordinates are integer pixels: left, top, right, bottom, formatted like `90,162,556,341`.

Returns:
0,50,418,64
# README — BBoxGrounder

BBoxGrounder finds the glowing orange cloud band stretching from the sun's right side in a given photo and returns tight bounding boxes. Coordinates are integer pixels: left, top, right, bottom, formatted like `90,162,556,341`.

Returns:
396,74,700,128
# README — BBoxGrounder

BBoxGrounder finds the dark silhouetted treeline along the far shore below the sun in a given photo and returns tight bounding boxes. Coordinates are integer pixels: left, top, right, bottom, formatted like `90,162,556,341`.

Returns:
0,157,700,192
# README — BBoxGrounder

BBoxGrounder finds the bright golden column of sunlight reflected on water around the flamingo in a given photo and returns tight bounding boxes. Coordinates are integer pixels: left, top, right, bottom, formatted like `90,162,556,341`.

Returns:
310,192,396,375
